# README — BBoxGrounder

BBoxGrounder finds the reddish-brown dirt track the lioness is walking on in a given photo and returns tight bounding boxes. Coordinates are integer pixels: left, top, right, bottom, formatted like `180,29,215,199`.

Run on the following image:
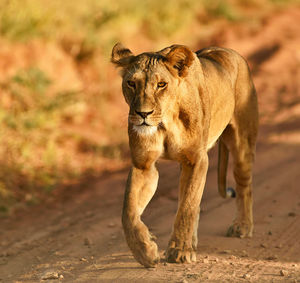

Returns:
0,7,300,283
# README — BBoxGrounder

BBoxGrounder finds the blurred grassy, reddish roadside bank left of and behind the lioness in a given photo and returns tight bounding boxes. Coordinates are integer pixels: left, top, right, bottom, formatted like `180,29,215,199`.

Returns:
0,0,299,214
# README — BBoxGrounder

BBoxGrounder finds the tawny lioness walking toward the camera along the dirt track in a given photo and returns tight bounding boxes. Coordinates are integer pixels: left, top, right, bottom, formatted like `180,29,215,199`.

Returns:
111,43,258,267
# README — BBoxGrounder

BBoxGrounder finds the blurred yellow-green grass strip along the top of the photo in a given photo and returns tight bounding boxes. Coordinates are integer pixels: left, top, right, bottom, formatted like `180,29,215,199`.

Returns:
0,0,299,51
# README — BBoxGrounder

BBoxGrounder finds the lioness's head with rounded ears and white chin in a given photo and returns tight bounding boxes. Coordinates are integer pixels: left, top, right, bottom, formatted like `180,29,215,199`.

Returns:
111,43,194,134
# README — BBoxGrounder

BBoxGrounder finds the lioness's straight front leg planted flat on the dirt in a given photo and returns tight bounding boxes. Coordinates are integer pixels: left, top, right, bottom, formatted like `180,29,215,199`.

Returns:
166,152,208,263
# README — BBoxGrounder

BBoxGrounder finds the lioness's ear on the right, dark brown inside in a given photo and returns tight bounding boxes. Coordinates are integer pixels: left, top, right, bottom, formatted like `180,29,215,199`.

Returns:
165,45,194,77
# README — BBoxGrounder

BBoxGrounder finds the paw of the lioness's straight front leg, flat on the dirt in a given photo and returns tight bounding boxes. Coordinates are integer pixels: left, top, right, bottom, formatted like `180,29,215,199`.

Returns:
166,241,196,263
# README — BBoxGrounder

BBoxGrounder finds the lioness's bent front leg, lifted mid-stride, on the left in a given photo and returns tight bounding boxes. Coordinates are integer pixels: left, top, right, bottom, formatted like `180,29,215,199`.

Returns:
122,164,159,267
